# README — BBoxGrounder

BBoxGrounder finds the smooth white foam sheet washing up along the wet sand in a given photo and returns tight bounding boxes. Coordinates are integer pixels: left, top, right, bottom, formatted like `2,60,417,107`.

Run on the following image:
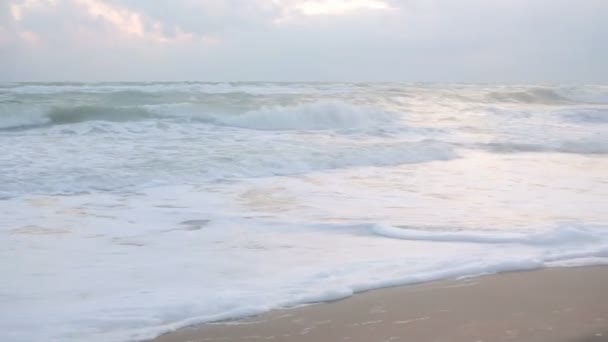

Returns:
0,192,608,342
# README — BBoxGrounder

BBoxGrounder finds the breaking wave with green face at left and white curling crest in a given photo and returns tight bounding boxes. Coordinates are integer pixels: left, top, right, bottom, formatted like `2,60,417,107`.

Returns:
0,102,404,130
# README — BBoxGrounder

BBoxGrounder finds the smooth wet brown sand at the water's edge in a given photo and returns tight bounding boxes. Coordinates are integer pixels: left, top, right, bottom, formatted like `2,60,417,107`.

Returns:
154,267,608,342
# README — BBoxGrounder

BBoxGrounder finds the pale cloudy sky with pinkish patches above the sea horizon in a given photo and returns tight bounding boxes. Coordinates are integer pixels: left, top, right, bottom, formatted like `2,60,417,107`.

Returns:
0,0,608,83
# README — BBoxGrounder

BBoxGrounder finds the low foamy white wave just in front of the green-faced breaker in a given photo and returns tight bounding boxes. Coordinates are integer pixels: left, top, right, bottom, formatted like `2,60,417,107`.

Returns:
0,138,459,198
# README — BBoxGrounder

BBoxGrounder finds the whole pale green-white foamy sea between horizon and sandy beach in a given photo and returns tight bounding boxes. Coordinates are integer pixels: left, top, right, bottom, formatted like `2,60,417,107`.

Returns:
0,82,608,342
